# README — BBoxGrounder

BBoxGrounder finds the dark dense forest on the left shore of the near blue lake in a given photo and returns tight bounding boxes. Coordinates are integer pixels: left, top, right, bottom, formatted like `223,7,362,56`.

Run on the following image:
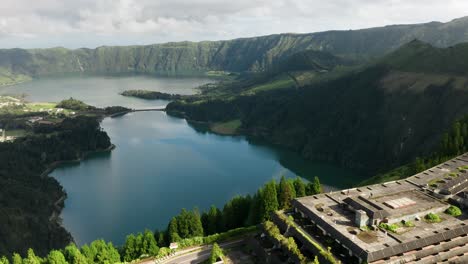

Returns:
0,116,111,255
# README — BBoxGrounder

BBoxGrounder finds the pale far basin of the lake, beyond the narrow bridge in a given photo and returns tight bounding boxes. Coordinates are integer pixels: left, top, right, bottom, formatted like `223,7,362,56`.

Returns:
0,75,208,108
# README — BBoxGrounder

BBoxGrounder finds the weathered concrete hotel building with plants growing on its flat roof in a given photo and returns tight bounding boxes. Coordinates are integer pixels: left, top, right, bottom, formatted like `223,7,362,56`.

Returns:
293,154,468,263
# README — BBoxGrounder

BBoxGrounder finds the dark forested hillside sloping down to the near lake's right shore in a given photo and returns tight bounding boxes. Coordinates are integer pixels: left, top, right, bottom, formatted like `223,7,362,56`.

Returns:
168,41,468,174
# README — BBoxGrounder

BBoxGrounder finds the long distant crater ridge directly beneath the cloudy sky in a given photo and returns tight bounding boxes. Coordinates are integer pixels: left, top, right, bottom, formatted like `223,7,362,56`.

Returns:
0,17,468,79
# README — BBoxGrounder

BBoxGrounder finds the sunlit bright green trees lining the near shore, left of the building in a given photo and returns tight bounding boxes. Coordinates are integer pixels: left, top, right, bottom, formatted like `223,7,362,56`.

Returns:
0,176,322,264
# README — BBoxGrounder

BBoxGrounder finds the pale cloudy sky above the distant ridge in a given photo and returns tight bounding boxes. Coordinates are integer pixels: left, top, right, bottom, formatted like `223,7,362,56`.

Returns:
0,0,468,48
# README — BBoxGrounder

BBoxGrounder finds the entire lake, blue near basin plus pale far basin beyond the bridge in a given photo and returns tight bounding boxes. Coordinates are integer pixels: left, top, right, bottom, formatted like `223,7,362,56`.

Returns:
0,76,363,245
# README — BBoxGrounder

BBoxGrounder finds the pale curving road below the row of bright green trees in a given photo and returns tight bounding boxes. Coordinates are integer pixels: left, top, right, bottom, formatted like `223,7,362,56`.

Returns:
140,239,245,264
